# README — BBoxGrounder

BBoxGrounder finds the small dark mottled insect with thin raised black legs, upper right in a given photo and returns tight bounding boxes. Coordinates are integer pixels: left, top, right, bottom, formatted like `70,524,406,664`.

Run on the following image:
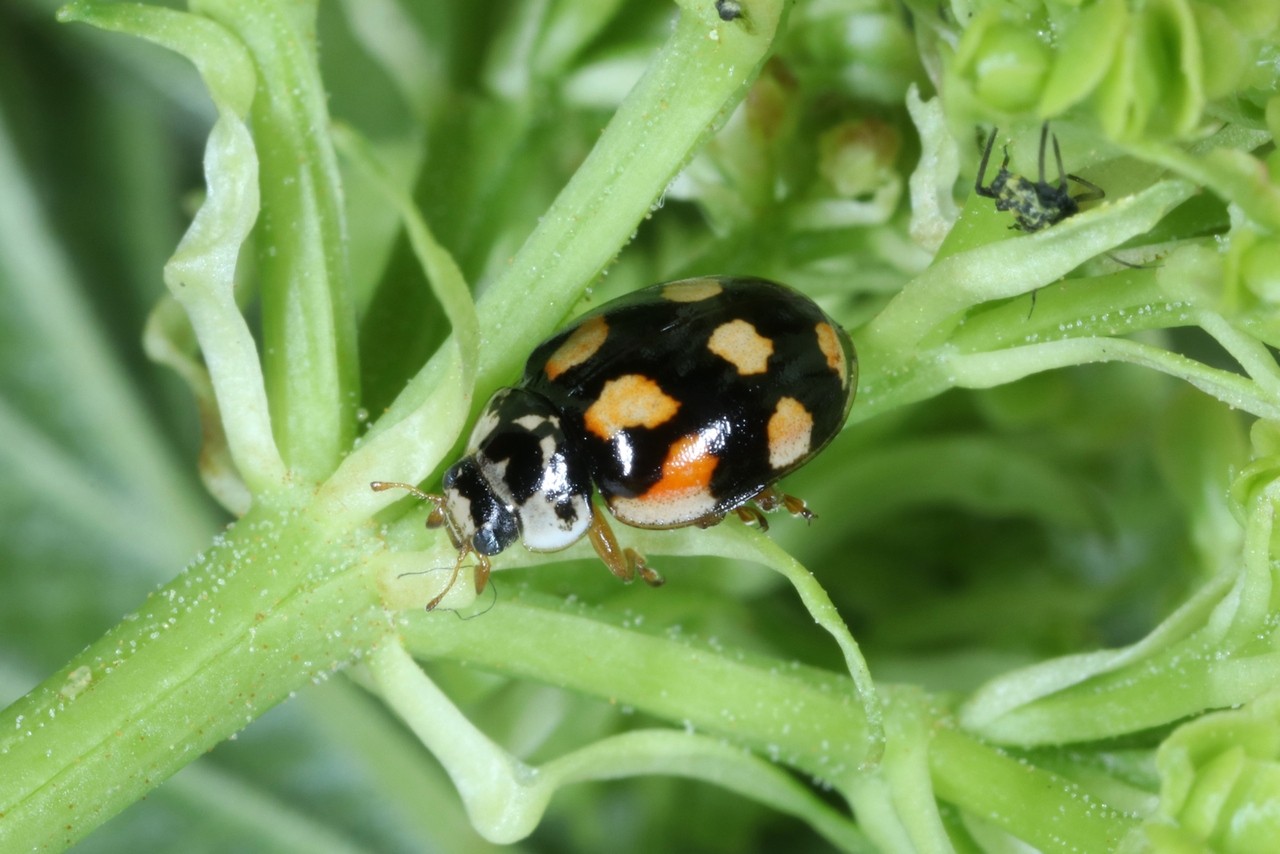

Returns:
973,122,1106,232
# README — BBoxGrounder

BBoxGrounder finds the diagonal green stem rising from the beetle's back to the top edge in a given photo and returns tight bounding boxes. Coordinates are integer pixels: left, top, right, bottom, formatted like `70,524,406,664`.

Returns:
479,0,786,389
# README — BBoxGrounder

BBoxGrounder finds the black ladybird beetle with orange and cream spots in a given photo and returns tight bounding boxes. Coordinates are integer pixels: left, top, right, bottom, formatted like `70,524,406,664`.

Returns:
372,277,858,609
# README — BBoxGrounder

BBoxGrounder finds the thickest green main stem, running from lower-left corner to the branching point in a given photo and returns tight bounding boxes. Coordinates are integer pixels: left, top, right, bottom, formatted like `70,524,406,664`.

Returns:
0,496,390,850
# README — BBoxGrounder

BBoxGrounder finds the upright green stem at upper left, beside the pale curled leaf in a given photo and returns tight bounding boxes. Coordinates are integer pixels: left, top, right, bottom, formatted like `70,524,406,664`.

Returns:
192,0,358,481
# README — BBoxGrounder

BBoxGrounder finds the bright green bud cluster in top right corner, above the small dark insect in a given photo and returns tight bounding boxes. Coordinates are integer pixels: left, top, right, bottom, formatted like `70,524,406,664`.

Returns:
941,0,1280,140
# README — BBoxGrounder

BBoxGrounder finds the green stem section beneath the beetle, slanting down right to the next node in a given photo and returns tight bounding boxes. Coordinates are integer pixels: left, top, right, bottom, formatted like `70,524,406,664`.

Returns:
403,602,868,780
